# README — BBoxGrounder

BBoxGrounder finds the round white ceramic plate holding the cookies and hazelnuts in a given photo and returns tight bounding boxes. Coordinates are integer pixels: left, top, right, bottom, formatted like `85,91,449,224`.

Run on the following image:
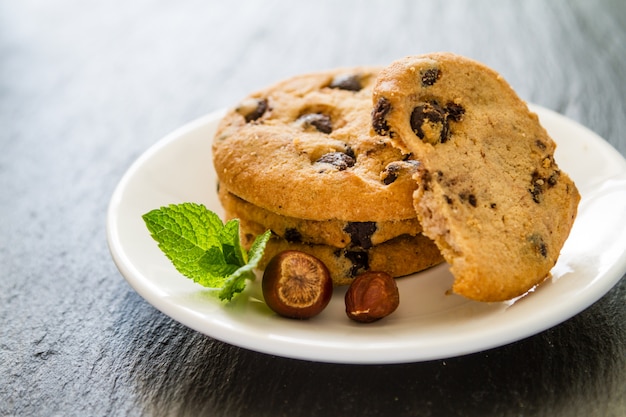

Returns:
107,106,626,364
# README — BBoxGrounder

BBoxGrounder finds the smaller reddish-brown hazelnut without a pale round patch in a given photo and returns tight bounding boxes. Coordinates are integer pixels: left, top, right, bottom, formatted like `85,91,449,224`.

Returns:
345,271,400,323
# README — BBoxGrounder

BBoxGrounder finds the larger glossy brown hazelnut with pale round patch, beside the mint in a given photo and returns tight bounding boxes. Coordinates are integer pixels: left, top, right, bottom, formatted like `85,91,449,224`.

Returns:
261,250,333,319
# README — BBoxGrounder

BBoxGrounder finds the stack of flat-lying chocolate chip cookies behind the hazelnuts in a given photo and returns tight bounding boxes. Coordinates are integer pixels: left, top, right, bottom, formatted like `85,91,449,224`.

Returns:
213,67,443,285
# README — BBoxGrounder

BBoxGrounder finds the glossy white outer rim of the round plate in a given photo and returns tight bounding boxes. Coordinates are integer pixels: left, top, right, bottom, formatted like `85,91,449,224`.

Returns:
106,104,626,364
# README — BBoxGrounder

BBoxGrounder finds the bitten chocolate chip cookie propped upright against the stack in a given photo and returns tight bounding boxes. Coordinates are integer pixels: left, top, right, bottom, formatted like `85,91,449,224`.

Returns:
372,53,580,301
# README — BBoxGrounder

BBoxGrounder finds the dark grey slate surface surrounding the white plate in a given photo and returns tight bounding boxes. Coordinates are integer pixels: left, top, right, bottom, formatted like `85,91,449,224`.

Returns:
0,0,626,416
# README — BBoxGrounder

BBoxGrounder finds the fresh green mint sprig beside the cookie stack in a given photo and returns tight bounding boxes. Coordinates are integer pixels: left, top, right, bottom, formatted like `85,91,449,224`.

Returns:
142,203,271,301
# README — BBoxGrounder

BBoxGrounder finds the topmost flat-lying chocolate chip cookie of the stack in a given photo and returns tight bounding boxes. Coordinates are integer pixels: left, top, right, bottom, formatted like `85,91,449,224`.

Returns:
213,67,417,222
